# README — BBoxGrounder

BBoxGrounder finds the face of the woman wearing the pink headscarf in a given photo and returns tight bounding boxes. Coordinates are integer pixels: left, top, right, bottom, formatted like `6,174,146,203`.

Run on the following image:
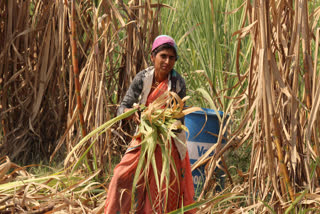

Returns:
151,48,176,78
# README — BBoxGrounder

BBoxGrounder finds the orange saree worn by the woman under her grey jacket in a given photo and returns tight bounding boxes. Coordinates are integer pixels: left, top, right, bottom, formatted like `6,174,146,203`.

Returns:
104,80,194,214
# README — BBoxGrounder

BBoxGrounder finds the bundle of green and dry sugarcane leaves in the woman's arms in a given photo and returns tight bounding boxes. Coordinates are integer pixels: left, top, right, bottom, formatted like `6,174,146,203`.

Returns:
131,91,203,209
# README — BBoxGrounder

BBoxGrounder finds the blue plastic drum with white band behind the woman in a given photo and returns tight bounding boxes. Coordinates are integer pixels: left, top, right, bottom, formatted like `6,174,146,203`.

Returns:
185,108,224,196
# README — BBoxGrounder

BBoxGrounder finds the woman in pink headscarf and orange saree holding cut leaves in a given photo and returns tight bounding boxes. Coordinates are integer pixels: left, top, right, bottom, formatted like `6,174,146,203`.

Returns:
105,35,194,214
